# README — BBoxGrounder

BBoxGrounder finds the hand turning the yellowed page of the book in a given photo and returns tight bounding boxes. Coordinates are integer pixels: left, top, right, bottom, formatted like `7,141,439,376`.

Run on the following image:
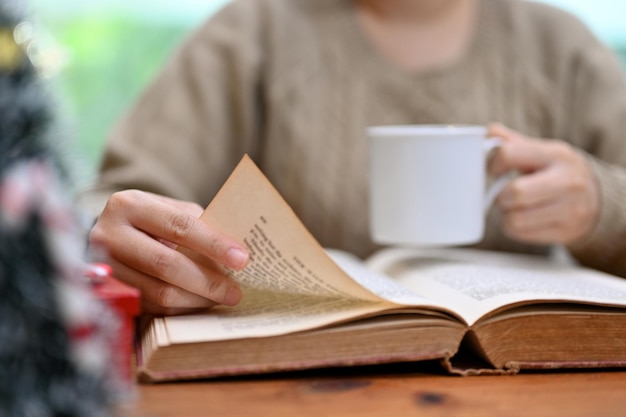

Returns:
89,190,249,314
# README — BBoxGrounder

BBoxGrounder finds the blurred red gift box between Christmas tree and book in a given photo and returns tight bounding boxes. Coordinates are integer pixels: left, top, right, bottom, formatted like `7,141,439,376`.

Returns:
86,264,140,384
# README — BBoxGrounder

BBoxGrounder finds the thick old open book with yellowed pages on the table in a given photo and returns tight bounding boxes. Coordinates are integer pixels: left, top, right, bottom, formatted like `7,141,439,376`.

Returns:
138,156,626,381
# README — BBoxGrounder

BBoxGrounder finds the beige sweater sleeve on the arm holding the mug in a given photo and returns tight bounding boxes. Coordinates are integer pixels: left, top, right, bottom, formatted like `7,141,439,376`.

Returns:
568,29,626,277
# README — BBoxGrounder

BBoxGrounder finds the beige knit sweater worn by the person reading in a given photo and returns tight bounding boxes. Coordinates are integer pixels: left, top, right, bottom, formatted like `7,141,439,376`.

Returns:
82,0,626,276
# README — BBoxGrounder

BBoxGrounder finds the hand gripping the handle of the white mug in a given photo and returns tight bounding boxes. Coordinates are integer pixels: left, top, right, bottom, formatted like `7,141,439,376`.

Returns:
488,125,600,245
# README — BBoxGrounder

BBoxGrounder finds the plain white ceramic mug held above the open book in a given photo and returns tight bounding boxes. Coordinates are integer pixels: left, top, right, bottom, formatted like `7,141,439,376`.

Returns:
367,125,510,246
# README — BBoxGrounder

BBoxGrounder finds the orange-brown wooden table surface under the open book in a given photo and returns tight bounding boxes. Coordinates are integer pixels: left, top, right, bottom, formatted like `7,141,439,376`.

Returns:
120,368,626,417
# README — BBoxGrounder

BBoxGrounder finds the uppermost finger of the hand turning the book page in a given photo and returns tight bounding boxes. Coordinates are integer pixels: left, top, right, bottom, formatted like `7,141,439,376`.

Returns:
108,193,249,269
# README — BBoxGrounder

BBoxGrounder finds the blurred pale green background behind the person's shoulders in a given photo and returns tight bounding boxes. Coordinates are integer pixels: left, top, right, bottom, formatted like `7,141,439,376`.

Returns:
30,0,626,181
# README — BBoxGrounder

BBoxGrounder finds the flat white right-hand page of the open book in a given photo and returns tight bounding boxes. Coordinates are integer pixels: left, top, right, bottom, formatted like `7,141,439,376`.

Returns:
368,248,626,325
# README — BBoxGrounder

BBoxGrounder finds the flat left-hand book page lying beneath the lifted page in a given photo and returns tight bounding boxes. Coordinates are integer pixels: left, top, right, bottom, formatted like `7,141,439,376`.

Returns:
166,250,466,343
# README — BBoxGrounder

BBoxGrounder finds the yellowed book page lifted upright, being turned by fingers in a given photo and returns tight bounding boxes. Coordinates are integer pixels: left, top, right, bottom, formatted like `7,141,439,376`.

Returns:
200,156,380,302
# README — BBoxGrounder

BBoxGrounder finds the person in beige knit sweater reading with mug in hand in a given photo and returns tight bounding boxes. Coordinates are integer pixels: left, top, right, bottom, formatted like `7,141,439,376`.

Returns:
82,0,626,314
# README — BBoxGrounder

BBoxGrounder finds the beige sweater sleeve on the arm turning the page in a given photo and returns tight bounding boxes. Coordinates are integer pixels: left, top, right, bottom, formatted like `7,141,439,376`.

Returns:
79,1,263,216
